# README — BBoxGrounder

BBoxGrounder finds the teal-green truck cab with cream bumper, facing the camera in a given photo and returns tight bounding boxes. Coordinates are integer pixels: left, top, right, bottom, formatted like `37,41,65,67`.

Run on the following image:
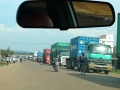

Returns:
85,43,112,74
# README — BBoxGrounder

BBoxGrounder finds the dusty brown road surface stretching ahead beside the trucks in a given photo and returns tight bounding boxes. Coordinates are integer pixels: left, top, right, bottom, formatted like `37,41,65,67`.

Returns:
0,61,120,90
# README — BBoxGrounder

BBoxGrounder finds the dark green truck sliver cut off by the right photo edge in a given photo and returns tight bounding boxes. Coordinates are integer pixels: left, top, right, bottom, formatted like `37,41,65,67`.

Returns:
116,13,120,68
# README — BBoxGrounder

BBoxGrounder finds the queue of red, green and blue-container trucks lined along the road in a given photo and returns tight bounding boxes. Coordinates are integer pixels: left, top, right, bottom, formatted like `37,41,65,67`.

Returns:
40,36,112,74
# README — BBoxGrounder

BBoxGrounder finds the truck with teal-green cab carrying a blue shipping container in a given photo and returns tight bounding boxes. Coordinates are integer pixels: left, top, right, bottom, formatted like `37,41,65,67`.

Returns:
66,36,112,74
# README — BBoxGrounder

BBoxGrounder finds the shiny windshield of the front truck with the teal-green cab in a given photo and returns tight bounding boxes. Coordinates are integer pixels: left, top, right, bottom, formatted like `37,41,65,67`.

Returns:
90,45,111,54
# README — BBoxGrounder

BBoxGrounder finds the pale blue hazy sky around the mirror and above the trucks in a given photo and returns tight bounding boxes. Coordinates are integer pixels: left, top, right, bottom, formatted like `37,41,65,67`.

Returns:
0,0,120,52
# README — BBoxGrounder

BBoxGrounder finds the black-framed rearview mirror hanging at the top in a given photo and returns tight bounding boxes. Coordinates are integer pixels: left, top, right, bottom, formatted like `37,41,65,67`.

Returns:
16,0,115,29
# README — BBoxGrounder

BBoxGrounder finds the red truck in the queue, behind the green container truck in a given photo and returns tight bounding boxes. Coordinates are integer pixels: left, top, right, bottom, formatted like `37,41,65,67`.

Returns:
43,48,51,64
